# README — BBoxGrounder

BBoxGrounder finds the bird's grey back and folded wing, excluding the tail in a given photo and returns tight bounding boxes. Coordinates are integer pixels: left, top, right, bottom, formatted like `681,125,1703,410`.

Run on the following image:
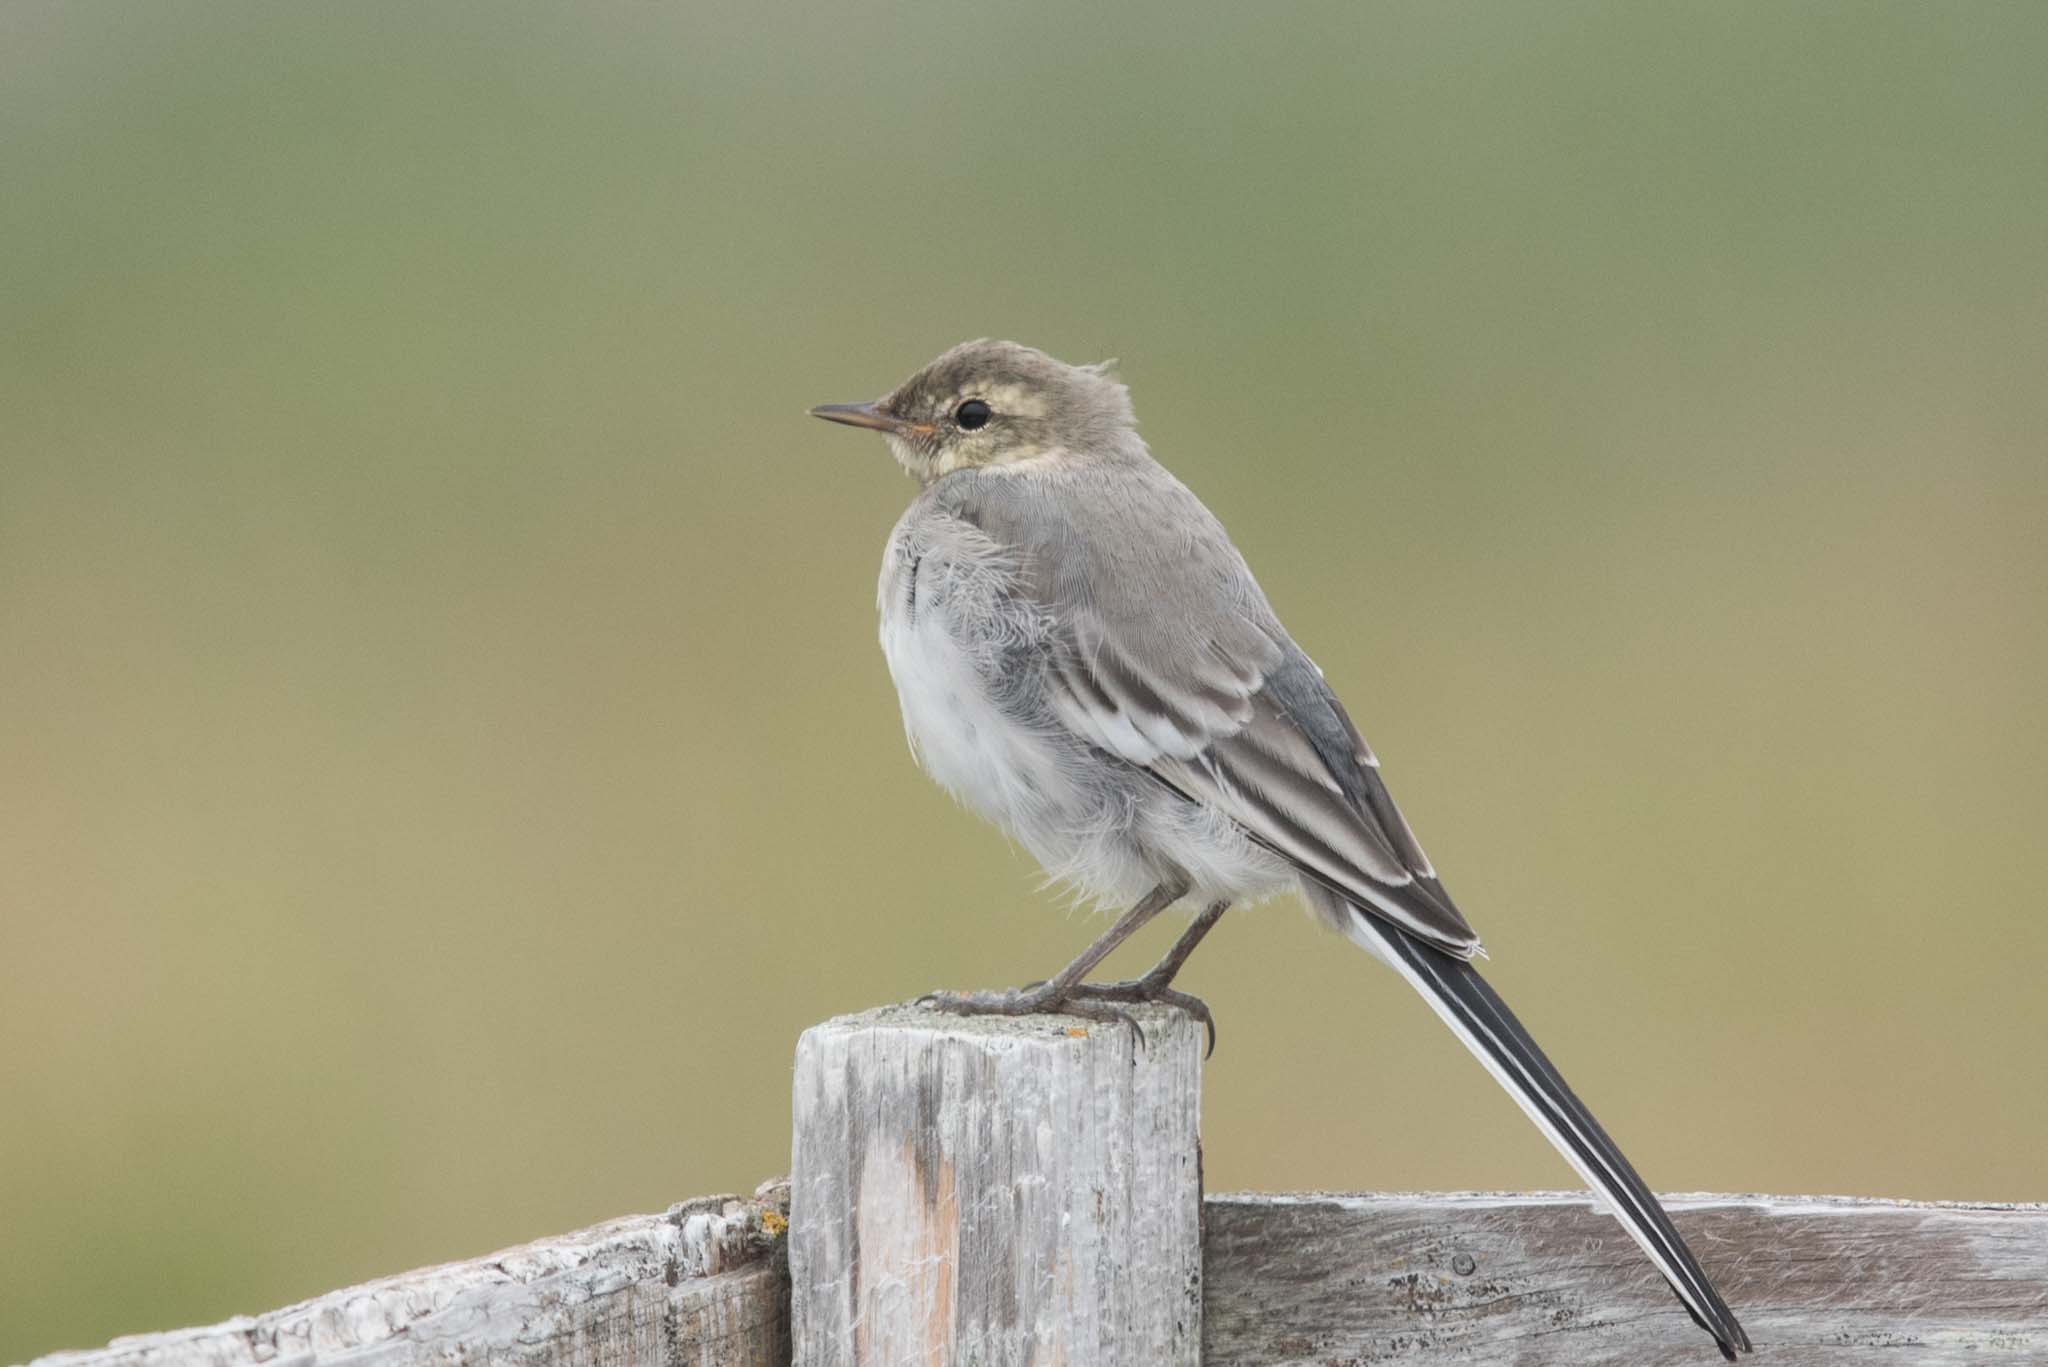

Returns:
928,459,1479,959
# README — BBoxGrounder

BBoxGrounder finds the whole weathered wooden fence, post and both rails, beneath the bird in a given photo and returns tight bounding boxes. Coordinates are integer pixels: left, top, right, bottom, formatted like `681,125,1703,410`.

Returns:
19,1006,2048,1367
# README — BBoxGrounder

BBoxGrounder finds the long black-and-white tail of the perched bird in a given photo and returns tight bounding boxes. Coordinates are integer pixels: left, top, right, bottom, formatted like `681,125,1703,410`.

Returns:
1343,908,1749,1363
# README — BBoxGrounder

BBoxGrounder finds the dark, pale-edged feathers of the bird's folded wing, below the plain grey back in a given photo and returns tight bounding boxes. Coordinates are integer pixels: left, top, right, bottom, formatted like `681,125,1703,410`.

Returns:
1051,600,1479,957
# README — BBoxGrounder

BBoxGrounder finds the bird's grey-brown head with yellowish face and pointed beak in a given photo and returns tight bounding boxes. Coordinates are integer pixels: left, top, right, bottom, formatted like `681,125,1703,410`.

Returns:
811,338,1135,484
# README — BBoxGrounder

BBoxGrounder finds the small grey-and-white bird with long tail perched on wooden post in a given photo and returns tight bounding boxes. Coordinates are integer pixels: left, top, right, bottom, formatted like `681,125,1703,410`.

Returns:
809,338,1751,1361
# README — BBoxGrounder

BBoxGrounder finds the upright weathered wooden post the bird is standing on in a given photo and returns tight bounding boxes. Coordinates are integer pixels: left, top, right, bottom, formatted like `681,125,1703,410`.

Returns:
788,1006,1204,1367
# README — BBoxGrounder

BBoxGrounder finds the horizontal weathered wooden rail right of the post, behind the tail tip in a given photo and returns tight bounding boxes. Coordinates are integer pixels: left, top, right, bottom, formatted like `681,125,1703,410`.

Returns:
1202,1193,2048,1367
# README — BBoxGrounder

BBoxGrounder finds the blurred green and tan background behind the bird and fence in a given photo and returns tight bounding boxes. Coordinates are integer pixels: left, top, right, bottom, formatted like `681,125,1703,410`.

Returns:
0,0,2048,1361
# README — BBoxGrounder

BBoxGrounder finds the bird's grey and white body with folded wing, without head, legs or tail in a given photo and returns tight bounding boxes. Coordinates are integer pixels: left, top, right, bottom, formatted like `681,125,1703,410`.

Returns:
879,413,1479,957
